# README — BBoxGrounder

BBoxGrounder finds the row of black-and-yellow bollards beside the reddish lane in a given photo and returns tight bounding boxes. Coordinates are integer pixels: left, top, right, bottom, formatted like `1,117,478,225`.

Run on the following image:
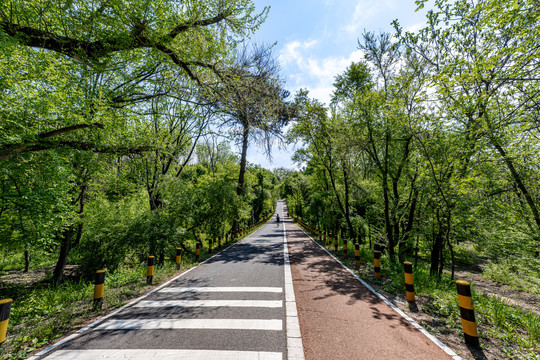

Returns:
292,216,480,347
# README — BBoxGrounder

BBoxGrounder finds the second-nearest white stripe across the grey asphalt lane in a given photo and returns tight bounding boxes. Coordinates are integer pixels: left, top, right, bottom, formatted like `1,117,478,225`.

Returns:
96,319,283,331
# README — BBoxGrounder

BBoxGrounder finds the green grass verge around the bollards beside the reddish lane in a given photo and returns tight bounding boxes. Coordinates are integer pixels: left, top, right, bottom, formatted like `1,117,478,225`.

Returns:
300,222,540,360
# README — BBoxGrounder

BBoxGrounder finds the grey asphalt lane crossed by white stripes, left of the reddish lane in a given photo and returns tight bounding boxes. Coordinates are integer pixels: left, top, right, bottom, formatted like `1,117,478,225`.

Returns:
37,203,303,360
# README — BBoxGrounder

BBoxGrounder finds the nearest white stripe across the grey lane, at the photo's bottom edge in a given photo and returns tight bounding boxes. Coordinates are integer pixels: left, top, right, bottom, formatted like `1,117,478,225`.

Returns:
42,349,283,360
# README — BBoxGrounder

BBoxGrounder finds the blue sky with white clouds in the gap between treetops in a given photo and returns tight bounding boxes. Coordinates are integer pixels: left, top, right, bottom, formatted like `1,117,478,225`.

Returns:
243,0,425,169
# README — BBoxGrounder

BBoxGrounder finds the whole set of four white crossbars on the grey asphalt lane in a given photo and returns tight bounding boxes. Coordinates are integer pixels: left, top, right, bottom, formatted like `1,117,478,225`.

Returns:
41,286,285,360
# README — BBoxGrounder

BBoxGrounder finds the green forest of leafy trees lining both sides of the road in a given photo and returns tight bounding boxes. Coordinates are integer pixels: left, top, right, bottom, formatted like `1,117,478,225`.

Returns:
0,0,540,359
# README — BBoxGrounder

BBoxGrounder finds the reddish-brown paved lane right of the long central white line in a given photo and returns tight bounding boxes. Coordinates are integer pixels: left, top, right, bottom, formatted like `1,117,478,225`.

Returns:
286,204,459,360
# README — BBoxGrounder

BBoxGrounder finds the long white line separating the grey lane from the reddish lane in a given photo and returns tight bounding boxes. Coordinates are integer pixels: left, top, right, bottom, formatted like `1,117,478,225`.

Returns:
281,203,304,360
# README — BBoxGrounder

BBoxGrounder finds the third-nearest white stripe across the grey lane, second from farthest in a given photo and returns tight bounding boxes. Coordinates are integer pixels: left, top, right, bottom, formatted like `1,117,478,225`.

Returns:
133,300,283,308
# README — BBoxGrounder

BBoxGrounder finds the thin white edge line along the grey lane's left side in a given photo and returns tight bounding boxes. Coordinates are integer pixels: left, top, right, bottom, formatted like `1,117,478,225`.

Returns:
27,219,272,360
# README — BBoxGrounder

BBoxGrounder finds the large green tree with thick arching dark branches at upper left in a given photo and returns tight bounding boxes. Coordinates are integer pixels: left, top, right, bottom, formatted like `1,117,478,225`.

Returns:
0,0,268,282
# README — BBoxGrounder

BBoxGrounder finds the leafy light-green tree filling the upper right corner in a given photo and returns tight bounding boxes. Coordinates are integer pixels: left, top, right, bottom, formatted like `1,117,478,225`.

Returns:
396,0,540,253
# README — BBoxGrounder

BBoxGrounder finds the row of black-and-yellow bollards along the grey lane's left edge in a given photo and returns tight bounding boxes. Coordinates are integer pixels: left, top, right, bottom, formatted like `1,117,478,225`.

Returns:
0,215,272,344
